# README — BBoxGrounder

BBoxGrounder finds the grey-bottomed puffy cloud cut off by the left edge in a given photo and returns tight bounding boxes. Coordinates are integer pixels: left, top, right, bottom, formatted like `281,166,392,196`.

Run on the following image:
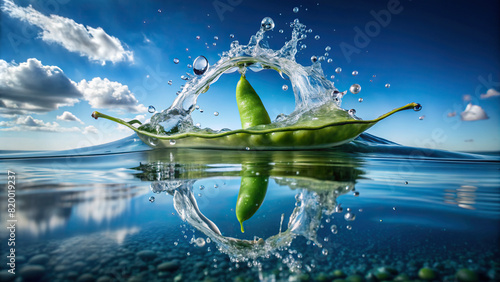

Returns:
0,58,83,115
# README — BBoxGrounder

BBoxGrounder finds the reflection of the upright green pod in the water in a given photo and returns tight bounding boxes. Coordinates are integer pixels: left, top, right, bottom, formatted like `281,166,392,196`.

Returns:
235,164,269,233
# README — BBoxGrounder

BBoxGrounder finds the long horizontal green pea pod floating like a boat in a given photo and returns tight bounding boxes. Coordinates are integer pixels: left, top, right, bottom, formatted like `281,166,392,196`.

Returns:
92,103,421,150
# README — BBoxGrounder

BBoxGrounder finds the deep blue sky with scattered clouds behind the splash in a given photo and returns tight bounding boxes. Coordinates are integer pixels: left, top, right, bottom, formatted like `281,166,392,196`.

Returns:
0,0,500,151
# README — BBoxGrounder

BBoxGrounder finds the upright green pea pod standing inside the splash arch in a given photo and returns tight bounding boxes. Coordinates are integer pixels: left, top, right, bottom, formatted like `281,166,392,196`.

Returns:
236,75,271,129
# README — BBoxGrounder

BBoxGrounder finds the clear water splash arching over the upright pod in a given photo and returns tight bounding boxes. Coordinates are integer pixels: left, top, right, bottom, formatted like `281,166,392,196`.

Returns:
146,17,345,135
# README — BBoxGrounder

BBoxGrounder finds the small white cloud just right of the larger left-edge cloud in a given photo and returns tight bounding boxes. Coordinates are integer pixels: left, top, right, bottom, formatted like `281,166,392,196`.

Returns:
78,77,147,113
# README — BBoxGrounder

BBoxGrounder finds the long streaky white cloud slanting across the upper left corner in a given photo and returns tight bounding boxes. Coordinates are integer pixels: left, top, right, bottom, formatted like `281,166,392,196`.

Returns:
2,0,134,65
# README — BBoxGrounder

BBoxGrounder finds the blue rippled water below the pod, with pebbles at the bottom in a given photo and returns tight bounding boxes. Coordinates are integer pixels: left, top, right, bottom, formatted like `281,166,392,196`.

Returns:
0,134,500,281
